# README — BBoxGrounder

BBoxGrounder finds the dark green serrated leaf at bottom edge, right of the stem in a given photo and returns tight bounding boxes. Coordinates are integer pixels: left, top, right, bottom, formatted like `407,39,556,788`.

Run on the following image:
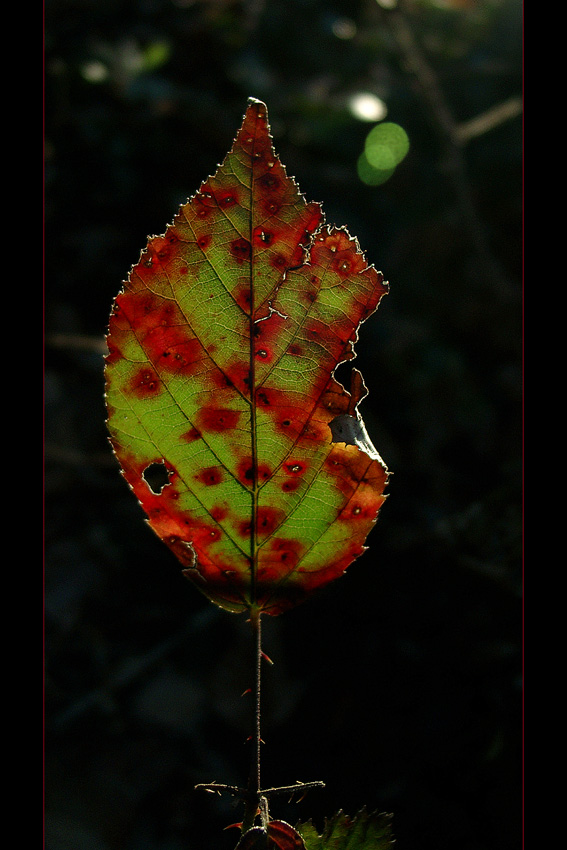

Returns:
296,809,395,850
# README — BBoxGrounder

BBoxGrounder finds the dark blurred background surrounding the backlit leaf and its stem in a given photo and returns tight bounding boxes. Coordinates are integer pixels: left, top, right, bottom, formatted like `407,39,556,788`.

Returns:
45,0,522,850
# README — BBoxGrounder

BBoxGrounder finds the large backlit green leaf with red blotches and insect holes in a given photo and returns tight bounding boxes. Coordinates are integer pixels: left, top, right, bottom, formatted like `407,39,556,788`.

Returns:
105,99,388,614
